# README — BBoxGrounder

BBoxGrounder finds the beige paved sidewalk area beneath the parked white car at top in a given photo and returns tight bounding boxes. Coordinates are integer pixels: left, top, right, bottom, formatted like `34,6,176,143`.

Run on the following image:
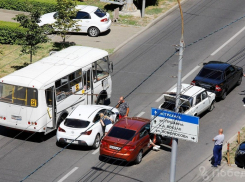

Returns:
0,9,144,50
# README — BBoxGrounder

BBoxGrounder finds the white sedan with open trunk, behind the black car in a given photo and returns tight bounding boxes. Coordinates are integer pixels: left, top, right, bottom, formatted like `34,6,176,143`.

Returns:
159,84,215,116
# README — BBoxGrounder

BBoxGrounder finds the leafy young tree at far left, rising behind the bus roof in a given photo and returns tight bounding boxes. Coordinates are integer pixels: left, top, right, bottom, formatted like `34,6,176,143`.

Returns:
13,8,50,62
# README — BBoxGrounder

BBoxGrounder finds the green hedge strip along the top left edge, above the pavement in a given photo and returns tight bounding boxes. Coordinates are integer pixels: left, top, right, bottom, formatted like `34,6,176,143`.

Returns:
0,0,56,14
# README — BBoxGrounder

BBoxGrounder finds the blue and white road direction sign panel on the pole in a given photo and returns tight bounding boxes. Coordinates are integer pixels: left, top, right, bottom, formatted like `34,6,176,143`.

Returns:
151,108,199,142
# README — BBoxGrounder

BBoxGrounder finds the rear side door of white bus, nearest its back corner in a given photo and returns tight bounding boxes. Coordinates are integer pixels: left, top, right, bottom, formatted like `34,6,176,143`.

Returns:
45,86,57,129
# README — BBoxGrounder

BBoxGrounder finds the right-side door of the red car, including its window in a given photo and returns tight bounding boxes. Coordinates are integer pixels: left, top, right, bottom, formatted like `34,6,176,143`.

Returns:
138,123,150,153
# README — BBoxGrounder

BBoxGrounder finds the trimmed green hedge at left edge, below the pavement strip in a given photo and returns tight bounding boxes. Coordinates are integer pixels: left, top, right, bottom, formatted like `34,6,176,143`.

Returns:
0,21,26,44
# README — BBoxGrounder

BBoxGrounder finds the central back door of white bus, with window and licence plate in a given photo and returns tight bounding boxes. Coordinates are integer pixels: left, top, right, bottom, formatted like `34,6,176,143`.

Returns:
7,85,28,126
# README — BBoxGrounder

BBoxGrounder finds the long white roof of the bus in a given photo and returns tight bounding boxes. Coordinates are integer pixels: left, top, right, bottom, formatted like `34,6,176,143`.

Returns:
0,46,108,89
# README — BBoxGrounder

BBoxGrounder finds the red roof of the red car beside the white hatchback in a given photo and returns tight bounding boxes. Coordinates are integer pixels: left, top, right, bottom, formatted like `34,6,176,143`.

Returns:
114,117,150,131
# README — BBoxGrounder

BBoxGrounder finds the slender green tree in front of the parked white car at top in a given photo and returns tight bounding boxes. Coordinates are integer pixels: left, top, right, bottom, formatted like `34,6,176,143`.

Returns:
52,0,80,43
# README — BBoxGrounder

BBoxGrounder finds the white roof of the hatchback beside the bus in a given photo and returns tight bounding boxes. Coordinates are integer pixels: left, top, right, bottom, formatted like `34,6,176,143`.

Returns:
67,105,111,120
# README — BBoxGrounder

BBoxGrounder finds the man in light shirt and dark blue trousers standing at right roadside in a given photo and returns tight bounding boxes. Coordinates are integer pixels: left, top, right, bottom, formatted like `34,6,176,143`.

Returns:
213,129,225,167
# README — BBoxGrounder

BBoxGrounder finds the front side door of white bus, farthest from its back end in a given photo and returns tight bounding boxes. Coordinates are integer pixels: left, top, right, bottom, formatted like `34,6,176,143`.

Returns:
83,68,94,104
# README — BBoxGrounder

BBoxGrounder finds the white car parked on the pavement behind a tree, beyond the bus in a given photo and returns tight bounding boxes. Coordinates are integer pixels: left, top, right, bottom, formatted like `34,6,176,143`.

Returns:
38,5,111,37
